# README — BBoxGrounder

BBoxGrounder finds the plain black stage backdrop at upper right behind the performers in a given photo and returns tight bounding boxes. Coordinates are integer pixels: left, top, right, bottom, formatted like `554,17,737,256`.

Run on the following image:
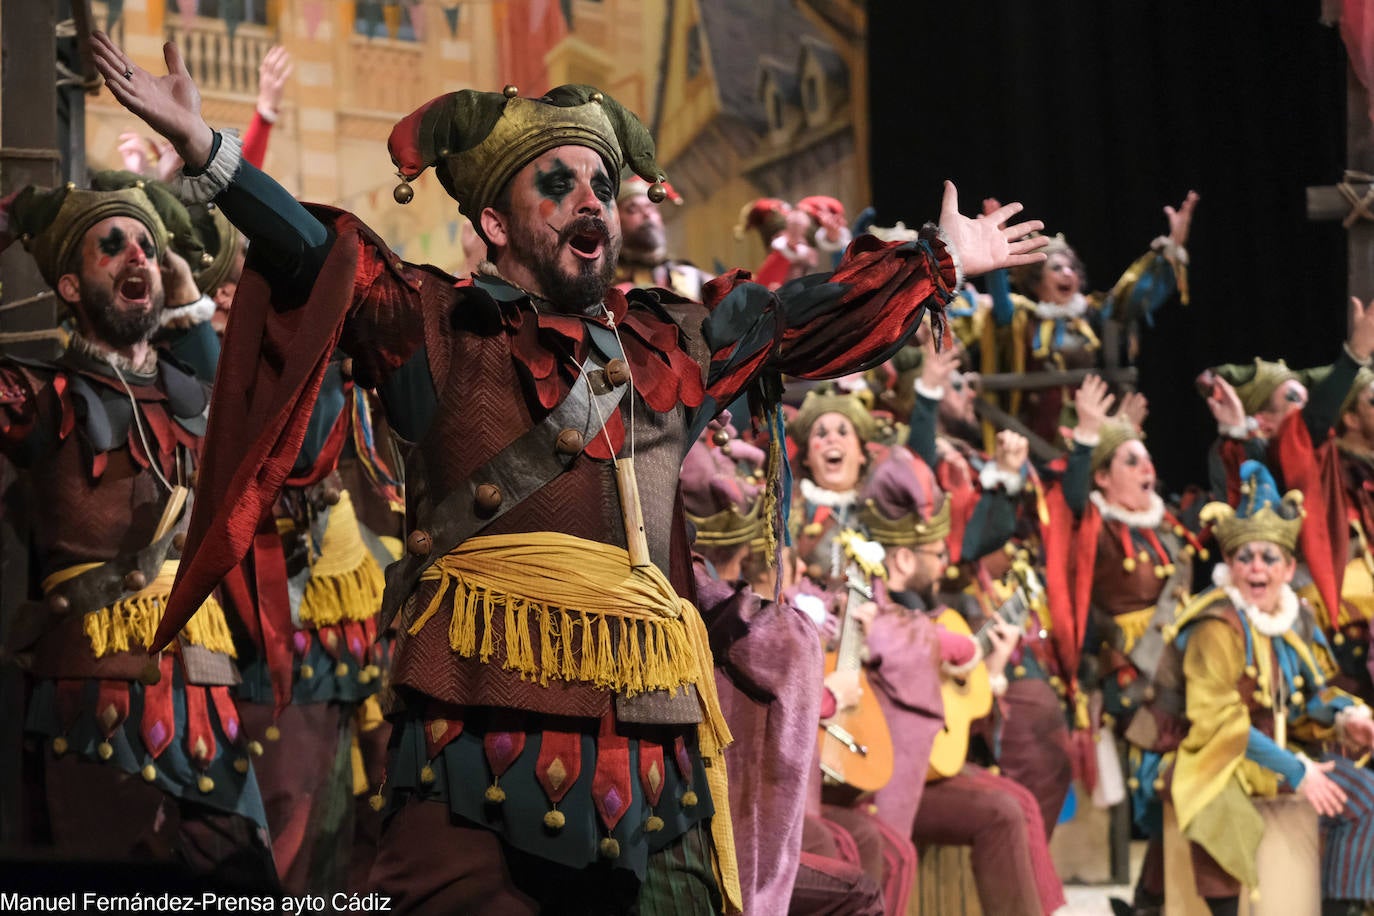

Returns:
868,0,1347,490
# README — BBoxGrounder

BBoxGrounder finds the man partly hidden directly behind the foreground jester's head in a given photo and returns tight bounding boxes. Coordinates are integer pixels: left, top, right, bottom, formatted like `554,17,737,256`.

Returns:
616,174,710,299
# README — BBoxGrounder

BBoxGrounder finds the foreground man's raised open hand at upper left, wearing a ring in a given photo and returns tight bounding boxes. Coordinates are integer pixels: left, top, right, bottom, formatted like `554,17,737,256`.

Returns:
91,32,214,168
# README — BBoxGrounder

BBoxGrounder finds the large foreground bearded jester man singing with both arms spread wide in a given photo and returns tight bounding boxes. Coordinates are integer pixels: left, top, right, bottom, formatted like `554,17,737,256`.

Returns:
93,36,1039,913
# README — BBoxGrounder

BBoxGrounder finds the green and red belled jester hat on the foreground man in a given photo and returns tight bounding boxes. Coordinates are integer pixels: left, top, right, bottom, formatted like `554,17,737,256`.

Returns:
386,84,668,240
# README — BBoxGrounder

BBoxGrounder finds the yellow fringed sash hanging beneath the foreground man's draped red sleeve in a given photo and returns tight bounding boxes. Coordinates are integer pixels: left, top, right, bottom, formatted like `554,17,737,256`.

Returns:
301,490,386,626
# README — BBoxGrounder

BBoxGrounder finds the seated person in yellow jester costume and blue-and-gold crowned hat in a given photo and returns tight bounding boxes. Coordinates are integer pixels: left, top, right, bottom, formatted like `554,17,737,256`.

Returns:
1161,461,1374,913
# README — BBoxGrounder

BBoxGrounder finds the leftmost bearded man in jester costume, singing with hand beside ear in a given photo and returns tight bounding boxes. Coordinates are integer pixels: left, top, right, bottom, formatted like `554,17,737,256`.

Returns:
0,173,275,887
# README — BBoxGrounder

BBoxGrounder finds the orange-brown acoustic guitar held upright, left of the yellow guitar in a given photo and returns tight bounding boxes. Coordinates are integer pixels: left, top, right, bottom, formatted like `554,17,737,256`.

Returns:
819,562,893,792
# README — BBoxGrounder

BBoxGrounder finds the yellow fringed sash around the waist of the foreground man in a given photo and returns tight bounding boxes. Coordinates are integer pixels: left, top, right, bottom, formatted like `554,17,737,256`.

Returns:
408,531,741,911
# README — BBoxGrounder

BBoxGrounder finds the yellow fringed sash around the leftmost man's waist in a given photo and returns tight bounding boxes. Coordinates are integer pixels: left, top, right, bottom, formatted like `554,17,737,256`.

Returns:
43,560,238,658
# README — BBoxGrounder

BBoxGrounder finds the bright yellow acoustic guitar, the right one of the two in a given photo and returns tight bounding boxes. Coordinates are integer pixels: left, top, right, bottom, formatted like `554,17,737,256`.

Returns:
926,563,1040,781
